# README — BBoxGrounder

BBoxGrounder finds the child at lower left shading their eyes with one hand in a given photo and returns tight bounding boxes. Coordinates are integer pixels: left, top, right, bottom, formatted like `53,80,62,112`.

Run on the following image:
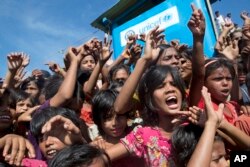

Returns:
30,107,86,160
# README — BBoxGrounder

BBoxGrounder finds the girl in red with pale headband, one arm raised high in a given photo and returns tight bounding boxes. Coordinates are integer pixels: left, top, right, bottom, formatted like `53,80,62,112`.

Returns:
188,3,250,134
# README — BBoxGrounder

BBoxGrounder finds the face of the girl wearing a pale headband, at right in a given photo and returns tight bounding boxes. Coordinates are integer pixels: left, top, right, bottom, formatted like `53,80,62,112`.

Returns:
205,67,233,102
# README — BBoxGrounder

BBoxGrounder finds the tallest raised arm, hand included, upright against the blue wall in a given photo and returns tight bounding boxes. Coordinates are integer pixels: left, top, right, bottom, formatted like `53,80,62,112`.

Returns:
188,4,205,106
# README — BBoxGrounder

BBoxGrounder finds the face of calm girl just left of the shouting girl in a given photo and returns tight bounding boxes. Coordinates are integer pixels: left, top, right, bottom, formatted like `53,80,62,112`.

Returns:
102,114,127,138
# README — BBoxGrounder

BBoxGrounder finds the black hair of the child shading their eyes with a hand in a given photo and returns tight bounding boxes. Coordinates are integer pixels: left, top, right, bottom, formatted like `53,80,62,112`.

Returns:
30,107,89,141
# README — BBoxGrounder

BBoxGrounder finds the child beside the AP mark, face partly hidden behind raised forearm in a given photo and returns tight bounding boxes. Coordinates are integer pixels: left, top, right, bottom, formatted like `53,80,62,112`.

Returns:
172,87,250,167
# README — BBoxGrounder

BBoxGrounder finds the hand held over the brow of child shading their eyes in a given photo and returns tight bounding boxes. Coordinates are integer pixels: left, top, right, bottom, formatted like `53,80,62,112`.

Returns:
42,115,84,145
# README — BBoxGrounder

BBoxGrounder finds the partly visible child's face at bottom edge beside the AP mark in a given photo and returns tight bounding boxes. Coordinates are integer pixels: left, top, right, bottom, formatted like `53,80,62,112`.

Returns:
210,141,229,167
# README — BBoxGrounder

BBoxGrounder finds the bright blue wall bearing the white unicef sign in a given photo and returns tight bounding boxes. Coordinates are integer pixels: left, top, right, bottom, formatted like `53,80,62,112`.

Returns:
112,0,216,59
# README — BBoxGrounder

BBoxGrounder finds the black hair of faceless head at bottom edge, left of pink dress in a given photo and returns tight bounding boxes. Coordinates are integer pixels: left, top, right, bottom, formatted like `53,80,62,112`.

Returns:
49,144,111,167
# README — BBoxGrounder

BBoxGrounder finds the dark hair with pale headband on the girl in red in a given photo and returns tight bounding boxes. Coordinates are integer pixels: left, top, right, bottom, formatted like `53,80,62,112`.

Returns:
204,57,236,80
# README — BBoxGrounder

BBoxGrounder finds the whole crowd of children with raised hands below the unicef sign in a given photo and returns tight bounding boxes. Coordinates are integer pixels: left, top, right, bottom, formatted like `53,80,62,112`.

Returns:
0,5,250,167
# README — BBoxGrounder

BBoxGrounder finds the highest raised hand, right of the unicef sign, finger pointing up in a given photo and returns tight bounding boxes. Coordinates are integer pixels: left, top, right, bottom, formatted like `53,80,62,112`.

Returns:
188,4,206,37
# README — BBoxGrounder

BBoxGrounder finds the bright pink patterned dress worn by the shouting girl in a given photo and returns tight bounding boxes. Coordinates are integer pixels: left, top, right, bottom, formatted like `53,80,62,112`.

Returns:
121,126,171,167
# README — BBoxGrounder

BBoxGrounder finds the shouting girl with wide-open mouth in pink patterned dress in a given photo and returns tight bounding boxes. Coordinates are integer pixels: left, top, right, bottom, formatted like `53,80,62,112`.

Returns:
107,64,189,166
